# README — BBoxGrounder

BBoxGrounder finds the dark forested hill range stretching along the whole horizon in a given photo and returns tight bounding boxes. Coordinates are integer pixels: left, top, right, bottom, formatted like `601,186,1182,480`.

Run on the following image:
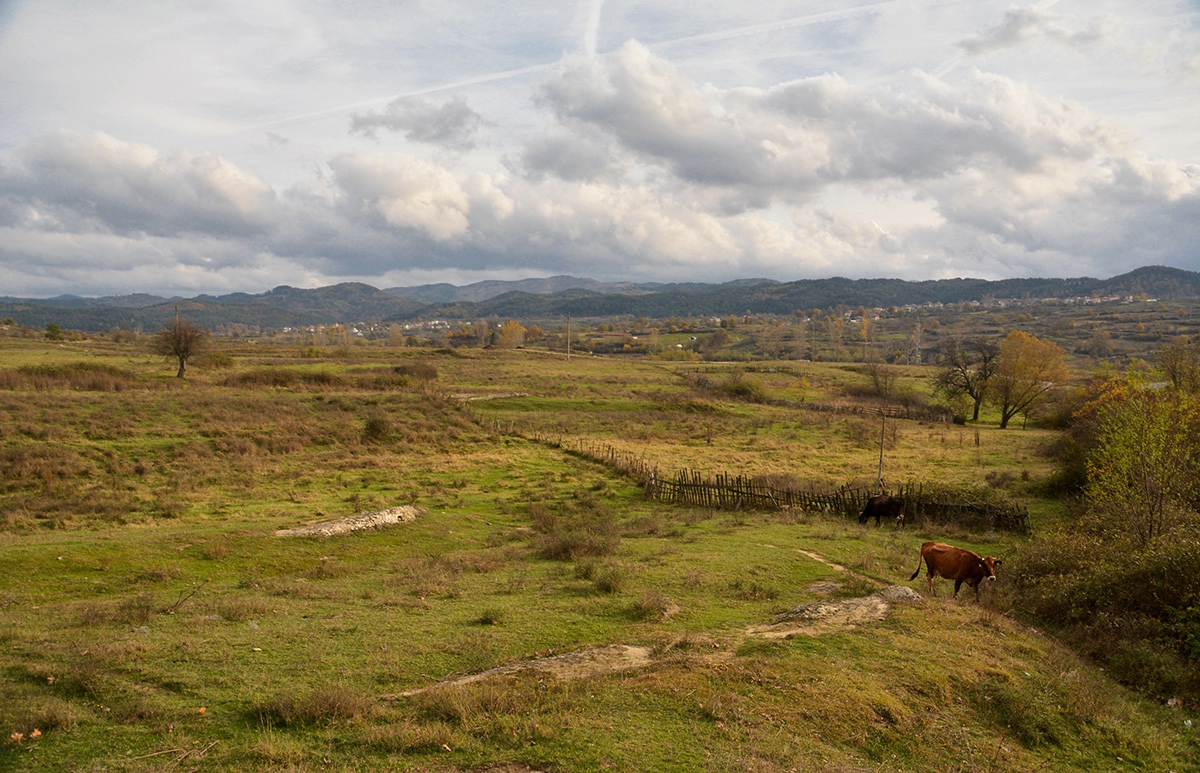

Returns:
0,266,1200,331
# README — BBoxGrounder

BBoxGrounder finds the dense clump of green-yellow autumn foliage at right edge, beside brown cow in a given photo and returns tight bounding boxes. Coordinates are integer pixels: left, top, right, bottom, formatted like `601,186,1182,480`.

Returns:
1006,377,1200,701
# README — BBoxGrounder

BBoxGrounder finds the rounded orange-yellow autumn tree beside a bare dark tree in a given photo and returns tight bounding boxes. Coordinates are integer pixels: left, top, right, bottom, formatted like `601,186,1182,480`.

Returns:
989,330,1070,430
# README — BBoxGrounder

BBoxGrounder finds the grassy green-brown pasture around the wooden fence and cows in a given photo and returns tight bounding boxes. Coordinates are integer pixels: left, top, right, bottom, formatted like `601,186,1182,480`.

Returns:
0,340,1200,772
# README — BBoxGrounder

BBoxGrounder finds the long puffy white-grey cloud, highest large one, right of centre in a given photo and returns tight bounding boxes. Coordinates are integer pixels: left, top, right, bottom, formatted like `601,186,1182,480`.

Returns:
535,42,1111,200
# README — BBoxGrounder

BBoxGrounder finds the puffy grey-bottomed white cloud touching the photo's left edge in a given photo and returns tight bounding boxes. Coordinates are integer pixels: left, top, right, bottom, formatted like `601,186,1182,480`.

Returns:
0,132,277,238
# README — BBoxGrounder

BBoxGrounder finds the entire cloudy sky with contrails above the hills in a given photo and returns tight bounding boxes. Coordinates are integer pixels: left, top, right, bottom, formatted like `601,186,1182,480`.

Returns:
0,0,1200,298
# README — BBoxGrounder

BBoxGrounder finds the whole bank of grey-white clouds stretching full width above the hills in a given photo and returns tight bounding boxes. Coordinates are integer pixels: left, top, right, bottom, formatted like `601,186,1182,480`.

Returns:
0,28,1200,298
